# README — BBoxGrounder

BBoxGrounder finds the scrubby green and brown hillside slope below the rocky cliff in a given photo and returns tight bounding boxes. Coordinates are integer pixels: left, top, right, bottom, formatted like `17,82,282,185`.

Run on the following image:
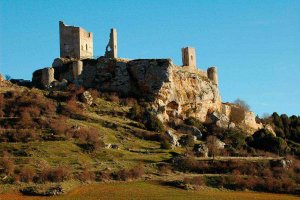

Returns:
0,86,300,199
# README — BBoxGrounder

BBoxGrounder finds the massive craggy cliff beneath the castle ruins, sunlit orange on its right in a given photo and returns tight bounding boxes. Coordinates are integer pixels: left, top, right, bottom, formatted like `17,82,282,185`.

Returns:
77,58,221,121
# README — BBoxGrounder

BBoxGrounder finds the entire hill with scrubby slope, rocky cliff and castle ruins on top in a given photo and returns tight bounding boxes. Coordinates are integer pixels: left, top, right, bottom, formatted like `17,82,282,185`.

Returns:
0,22,300,198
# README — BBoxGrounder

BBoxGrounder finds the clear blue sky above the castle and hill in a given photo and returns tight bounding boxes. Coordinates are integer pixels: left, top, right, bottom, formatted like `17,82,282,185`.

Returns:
0,0,300,115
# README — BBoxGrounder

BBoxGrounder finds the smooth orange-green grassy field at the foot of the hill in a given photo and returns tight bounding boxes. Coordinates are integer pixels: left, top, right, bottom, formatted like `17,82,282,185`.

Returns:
0,182,300,200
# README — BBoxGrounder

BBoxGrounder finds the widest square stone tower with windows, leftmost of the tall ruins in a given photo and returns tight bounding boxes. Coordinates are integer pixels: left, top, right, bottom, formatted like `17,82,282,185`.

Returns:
59,21,94,59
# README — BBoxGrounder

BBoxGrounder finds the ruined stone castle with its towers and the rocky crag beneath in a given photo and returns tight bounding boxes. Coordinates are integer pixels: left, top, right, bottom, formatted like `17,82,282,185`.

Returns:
32,22,257,129
